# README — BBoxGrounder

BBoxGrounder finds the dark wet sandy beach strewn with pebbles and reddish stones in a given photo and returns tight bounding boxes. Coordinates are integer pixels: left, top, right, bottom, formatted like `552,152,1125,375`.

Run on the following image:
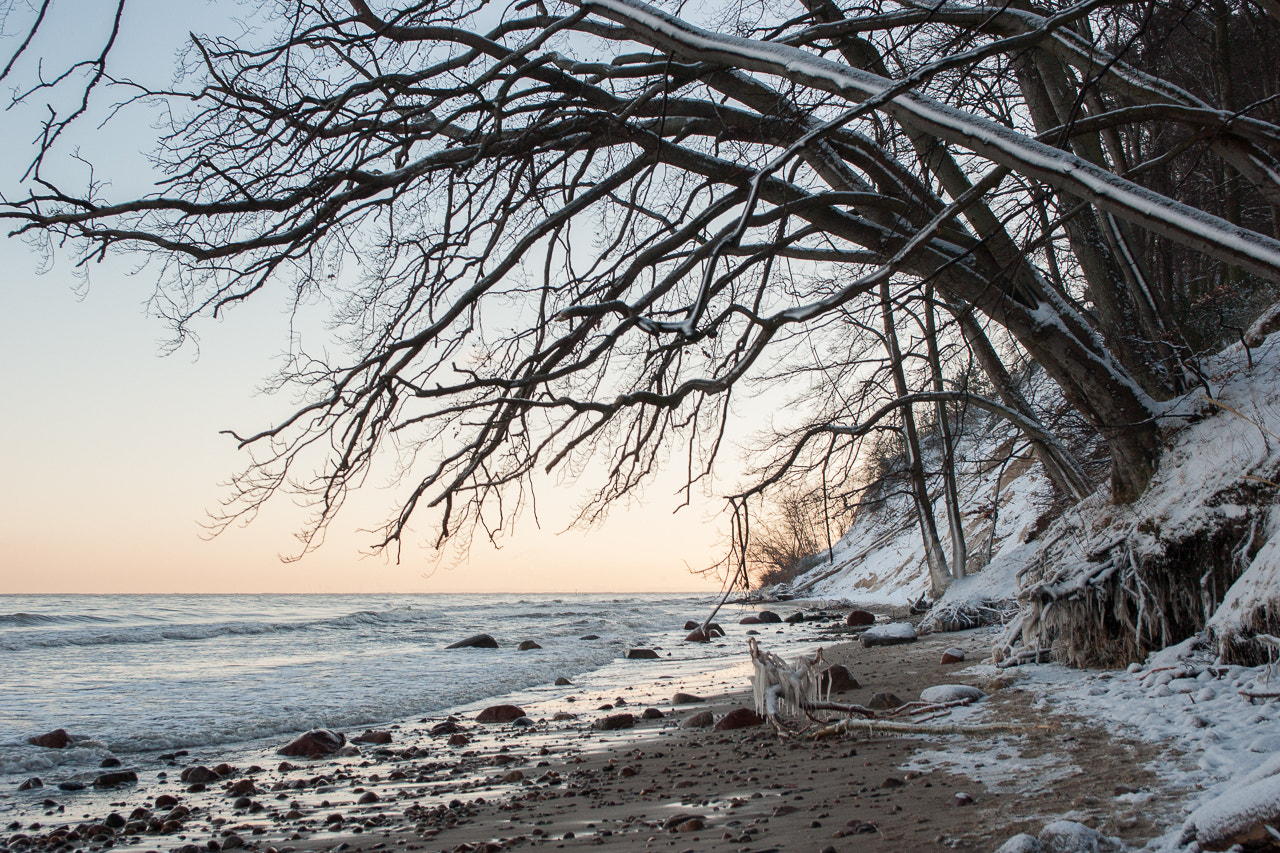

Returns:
0,614,1179,853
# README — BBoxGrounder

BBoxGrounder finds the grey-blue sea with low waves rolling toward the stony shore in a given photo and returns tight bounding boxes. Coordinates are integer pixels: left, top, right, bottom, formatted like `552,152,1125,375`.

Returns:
0,594,829,811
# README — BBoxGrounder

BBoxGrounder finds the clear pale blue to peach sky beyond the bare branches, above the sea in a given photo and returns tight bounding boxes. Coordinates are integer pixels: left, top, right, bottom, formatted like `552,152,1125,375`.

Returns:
0,0,726,594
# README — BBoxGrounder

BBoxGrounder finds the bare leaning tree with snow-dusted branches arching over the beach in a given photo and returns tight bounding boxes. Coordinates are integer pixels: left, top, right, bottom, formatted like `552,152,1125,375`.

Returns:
0,0,1280,645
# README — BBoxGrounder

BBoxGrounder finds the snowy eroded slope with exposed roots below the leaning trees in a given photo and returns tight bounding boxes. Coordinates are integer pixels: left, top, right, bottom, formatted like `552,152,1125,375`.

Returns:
794,318,1280,665
